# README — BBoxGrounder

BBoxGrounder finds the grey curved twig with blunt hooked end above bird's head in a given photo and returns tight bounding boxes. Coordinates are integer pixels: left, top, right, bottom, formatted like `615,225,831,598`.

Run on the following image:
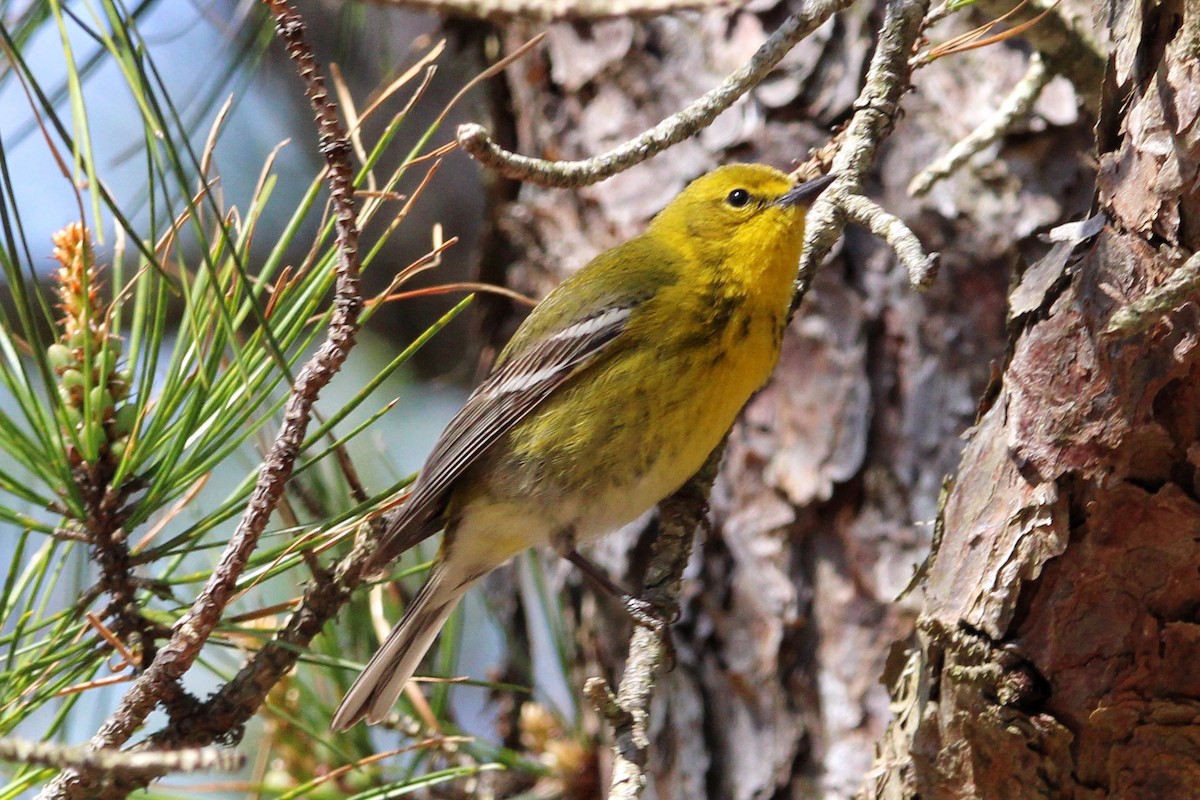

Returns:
458,0,851,187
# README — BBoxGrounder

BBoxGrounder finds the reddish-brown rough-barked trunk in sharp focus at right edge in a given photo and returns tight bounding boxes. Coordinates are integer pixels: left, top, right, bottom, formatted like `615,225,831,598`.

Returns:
864,2,1200,800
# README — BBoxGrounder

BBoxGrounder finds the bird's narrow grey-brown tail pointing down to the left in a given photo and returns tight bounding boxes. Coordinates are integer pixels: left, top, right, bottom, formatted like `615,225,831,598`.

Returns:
329,565,473,730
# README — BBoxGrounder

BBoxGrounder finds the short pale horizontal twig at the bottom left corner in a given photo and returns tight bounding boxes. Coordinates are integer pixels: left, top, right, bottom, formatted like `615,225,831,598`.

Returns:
0,739,246,774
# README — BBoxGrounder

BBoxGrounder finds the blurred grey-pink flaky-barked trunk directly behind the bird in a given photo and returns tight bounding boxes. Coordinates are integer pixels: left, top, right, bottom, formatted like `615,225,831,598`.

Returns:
472,1,1124,799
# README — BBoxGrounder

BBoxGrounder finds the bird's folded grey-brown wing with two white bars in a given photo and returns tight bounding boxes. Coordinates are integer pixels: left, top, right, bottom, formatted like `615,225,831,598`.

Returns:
368,296,646,571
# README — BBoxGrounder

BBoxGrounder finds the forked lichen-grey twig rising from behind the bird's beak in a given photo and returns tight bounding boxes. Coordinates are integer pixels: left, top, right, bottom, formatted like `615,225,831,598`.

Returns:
797,0,934,295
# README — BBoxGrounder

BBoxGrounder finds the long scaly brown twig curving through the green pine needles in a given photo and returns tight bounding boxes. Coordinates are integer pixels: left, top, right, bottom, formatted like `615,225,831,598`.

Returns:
41,0,362,799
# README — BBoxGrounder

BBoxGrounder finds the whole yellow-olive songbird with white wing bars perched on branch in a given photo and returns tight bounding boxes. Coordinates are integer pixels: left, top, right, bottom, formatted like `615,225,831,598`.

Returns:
331,164,832,730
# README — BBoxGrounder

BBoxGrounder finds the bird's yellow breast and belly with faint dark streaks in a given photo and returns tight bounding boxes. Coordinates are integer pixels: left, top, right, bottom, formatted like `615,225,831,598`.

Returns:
488,287,782,539
